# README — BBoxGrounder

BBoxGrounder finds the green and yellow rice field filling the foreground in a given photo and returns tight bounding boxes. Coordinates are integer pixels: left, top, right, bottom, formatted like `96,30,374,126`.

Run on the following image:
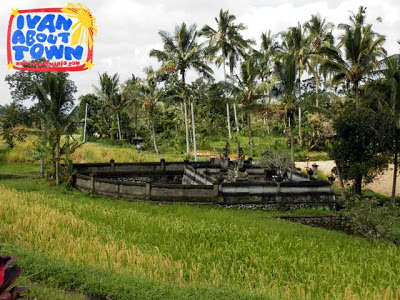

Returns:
0,171,400,299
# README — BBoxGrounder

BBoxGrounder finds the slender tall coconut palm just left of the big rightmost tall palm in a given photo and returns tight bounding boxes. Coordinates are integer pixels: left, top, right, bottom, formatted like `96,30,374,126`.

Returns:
304,15,334,107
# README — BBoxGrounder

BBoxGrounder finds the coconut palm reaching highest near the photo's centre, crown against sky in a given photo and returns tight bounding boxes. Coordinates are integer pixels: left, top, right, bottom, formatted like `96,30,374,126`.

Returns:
200,9,254,139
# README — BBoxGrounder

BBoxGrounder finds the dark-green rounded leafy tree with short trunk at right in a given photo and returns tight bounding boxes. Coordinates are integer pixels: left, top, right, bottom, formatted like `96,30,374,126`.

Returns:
331,109,395,194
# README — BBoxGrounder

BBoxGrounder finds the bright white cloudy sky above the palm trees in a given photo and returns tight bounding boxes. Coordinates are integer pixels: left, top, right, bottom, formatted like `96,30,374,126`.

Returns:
0,0,400,105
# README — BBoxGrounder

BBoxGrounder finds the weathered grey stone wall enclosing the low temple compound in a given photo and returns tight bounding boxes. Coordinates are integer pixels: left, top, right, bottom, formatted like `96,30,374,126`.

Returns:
74,160,336,209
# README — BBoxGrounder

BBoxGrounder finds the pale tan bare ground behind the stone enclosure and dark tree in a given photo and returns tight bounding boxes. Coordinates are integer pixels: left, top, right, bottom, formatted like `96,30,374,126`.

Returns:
296,160,400,196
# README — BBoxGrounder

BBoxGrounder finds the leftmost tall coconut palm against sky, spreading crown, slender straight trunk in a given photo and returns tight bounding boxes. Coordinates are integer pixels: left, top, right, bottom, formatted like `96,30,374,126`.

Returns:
150,23,213,154
